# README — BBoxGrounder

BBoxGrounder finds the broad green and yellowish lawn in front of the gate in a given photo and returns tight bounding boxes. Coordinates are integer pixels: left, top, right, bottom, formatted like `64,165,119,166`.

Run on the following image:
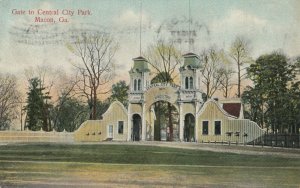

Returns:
0,144,300,187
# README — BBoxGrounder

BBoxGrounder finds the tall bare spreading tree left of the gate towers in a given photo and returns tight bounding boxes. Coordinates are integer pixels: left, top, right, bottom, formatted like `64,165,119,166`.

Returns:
68,32,118,119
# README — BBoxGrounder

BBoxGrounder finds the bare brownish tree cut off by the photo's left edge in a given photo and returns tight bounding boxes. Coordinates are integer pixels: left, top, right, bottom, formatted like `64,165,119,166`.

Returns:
0,74,20,130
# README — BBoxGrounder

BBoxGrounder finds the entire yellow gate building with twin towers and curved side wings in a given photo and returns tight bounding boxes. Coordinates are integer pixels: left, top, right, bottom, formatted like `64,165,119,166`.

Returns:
75,53,264,143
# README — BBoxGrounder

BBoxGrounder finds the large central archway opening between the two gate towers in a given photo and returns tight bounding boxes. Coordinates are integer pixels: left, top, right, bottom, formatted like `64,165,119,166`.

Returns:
151,101,179,141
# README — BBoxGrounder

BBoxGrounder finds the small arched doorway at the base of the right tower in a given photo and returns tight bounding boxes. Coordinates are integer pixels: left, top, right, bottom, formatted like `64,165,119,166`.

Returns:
183,114,195,142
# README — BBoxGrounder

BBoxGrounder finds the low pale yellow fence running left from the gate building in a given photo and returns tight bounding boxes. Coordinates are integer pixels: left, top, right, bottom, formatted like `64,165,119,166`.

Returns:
0,131,74,143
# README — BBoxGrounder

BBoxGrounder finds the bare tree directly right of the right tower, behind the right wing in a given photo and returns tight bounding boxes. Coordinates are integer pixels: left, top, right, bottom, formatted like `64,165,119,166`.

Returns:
200,47,224,98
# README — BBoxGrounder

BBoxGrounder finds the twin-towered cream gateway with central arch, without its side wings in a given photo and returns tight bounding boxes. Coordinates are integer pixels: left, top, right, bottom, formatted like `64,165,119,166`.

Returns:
128,53,203,141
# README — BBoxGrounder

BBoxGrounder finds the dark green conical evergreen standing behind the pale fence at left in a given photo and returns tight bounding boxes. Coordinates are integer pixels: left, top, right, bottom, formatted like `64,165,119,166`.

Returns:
25,78,52,131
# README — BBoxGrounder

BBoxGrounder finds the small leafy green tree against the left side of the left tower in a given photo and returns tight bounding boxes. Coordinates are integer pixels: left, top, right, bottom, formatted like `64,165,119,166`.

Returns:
108,80,129,107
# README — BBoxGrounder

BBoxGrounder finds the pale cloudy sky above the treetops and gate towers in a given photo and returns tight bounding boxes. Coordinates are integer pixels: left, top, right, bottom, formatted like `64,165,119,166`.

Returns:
0,0,300,83
